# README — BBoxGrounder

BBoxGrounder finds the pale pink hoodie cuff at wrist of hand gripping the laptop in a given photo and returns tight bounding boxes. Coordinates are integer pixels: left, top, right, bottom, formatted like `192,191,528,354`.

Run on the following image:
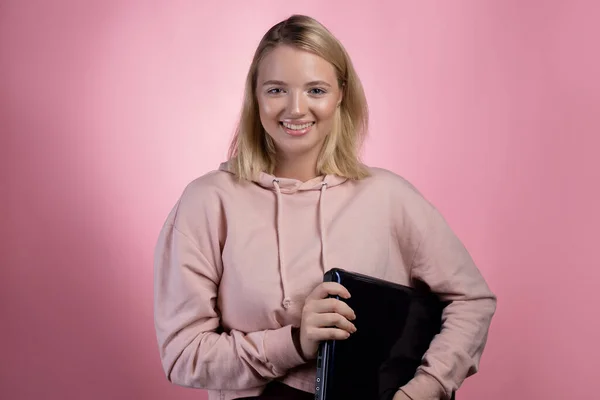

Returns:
264,325,306,372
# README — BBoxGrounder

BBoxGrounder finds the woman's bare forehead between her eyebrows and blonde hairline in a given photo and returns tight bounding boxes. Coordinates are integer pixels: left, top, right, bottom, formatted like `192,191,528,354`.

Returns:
258,45,337,85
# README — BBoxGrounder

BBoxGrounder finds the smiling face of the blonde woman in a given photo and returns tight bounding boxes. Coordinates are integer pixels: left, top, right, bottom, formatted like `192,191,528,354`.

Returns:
256,45,342,162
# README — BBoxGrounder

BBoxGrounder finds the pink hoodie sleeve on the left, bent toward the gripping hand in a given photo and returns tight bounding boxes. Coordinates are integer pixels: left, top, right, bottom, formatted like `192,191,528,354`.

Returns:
154,181,303,390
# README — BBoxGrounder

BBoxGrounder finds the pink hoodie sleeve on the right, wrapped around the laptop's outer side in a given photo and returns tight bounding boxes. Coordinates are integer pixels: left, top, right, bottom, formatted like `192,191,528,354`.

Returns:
401,200,496,400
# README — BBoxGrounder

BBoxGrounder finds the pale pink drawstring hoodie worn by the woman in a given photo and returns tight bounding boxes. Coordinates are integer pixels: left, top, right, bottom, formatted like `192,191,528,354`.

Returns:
154,163,496,400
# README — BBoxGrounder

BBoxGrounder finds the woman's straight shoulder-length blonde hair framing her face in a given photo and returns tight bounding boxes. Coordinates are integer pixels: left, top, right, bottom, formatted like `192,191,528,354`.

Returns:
229,15,369,180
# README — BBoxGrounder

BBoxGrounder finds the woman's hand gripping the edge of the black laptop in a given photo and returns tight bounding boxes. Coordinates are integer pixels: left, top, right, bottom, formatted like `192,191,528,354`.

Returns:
300,282,356,360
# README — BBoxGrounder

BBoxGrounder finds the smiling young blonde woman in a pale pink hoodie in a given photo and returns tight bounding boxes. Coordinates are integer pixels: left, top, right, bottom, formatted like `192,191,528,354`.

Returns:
155,16,496,400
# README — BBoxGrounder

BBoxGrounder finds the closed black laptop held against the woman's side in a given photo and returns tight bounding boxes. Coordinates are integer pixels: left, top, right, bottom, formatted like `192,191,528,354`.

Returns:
315,268,444,400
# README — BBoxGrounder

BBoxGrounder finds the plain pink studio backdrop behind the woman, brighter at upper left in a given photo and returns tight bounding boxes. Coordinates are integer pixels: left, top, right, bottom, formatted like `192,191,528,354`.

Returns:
0,0,600,400
